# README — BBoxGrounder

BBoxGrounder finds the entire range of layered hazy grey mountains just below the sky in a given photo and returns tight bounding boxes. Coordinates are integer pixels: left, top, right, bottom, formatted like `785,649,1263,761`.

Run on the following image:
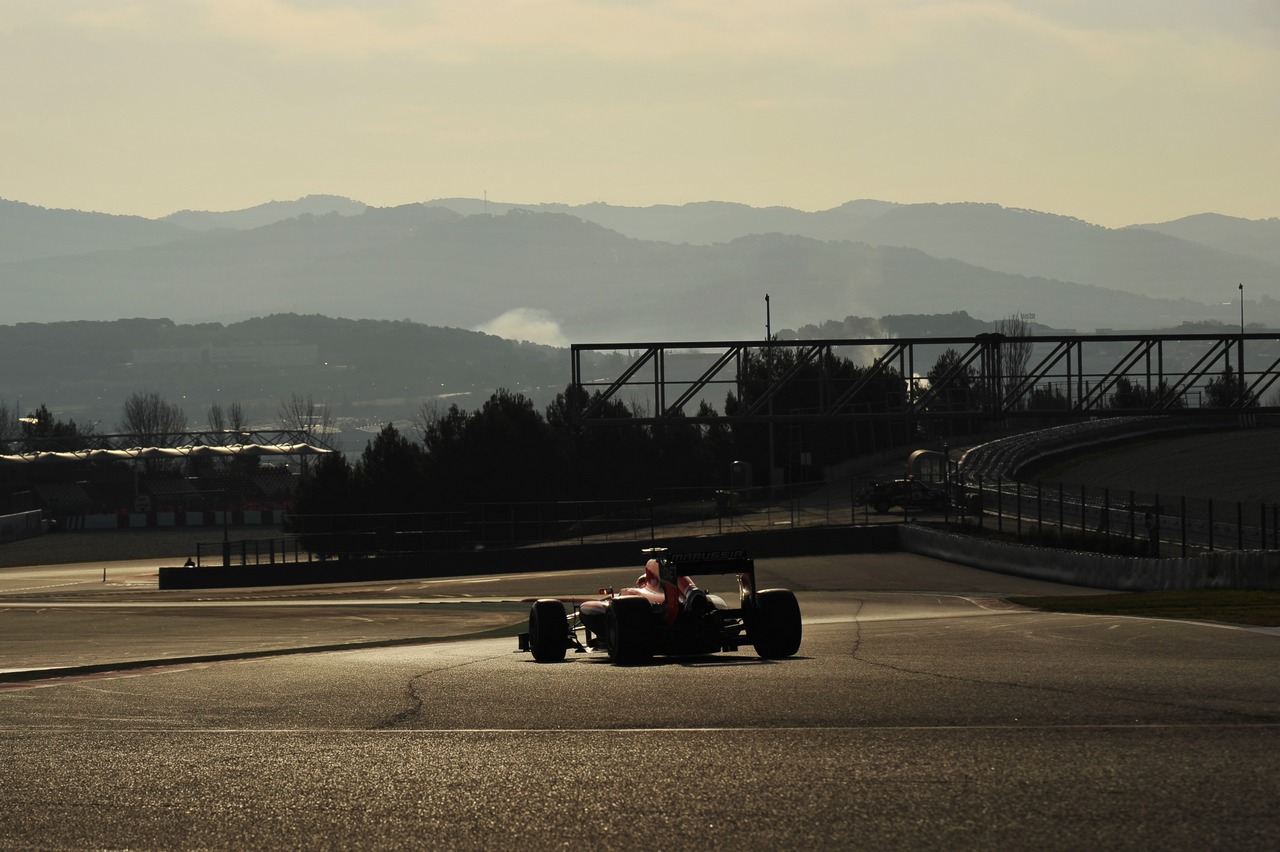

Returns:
0,196,1280,342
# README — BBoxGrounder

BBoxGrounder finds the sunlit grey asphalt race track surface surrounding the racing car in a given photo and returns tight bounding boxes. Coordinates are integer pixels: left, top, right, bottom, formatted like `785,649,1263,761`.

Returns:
0,554,1280,849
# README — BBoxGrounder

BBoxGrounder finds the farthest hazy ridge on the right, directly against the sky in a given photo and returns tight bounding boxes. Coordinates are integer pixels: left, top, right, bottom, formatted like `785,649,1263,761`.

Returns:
417,200,1280,303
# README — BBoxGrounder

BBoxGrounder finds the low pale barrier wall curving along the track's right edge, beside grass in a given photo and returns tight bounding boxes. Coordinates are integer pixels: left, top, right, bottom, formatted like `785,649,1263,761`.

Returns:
899,523,1280,591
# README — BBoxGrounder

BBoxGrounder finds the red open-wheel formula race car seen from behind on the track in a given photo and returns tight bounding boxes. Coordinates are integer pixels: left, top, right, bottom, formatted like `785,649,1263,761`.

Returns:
520,548,800,665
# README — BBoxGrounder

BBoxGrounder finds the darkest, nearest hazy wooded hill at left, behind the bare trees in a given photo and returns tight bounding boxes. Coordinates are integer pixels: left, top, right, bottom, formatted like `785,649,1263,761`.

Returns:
0,313,570,427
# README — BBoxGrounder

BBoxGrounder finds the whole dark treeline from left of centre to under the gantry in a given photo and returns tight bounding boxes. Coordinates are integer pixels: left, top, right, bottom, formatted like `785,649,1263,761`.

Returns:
286,348,909,527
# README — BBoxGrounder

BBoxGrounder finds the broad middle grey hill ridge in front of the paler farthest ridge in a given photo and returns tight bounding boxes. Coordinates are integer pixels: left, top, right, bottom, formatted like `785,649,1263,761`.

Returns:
0,205,1244,342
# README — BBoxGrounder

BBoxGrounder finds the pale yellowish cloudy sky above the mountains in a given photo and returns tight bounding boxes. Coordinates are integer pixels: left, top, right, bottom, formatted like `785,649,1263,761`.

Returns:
0,0,1280,226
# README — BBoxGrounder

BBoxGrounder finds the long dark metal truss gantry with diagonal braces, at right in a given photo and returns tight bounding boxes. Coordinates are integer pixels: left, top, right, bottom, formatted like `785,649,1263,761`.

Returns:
571,331,1280,422
